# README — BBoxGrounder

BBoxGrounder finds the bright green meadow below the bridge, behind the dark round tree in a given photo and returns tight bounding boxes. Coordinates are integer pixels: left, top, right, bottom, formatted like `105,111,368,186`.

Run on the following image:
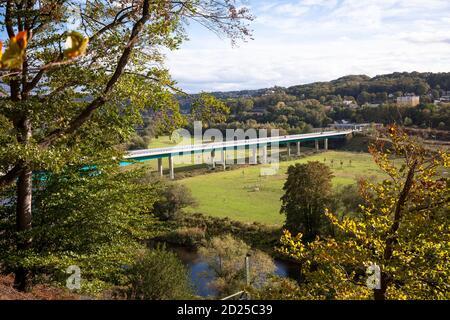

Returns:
179,151,382,225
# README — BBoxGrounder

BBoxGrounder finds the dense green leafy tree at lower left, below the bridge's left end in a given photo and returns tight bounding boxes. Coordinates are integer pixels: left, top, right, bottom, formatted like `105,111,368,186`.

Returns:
0,163,161,294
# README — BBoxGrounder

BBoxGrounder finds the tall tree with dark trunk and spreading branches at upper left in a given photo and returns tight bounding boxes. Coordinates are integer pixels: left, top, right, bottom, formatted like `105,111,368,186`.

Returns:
0,0,251,290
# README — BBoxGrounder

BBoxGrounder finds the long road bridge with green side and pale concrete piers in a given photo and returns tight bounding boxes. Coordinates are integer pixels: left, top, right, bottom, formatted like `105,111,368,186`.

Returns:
121,130,359,179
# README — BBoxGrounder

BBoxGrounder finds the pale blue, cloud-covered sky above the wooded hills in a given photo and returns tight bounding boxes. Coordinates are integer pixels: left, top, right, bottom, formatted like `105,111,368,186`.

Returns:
166,0,450,93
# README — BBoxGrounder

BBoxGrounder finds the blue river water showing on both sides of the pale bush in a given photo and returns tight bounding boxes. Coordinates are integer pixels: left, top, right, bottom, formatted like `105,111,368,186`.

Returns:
169,246,299,297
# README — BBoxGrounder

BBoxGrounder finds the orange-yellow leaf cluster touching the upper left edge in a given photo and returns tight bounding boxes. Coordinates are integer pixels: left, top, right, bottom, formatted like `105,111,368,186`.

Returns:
0,31,28,69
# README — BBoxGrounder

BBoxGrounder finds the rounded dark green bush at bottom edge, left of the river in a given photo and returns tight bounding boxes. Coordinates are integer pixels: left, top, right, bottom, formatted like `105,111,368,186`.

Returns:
127,248,193,300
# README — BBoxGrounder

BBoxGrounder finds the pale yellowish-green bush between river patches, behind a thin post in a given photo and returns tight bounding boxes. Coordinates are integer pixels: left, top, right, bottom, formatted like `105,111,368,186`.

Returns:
200,235,275,295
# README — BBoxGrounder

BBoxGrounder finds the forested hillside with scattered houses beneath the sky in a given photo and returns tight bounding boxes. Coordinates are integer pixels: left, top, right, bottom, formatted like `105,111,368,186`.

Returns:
179,72,450,133
